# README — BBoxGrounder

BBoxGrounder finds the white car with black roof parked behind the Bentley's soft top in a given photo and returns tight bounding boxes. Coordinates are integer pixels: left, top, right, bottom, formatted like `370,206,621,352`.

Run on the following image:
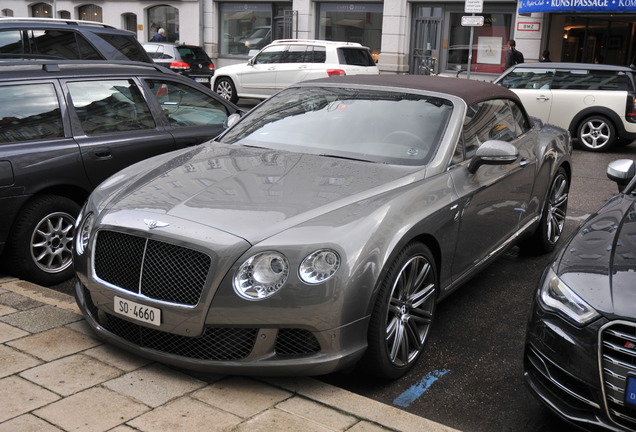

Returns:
495,63,636,151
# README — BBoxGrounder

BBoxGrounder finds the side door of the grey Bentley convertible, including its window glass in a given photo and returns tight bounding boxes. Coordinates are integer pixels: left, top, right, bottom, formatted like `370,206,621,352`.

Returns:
452,99,537,275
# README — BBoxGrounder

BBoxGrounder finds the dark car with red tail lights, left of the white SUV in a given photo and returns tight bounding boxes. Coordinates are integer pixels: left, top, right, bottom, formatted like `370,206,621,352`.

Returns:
143,42,214,87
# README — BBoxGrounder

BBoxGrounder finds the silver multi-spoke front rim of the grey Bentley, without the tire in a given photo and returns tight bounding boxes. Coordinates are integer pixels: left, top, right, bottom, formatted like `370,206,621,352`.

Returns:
386,255,436,367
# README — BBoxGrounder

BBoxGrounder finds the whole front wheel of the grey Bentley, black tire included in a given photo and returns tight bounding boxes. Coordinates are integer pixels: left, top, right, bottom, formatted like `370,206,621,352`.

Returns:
362,243,438,379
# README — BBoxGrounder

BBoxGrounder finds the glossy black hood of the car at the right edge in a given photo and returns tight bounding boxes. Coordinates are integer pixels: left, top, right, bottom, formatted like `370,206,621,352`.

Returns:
557,195,636,318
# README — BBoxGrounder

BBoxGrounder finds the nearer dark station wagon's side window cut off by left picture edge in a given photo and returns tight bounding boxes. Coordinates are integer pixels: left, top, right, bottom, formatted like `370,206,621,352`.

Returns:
0,83,64,143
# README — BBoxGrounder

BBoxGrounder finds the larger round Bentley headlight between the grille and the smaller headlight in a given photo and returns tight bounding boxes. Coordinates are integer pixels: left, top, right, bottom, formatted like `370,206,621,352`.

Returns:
234,252,289,300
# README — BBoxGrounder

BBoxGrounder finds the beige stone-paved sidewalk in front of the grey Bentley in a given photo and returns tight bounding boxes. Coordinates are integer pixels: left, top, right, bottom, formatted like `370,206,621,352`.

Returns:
0,277,454,432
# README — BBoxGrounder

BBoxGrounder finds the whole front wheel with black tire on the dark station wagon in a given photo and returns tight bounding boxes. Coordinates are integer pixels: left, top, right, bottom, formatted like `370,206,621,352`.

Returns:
5,195,80,286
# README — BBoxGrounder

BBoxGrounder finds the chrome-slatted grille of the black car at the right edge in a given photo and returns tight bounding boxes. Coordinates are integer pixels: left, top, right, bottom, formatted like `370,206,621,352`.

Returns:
601,323,636,429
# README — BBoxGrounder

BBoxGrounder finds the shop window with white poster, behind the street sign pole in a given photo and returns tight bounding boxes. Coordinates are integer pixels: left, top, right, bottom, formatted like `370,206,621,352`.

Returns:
446,13,512,74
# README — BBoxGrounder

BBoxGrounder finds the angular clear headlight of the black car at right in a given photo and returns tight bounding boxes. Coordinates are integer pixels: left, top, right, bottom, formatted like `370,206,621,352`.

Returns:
539,268,600,325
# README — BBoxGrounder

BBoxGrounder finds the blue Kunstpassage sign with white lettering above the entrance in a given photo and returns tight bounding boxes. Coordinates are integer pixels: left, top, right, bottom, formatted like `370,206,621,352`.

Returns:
519,0,636,13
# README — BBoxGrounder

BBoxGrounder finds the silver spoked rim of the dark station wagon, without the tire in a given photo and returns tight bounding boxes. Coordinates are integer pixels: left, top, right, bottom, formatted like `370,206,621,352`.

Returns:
31,212,75,273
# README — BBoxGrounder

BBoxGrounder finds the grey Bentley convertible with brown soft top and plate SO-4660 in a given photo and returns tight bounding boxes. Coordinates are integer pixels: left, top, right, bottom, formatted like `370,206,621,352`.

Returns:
74,75,571,378
